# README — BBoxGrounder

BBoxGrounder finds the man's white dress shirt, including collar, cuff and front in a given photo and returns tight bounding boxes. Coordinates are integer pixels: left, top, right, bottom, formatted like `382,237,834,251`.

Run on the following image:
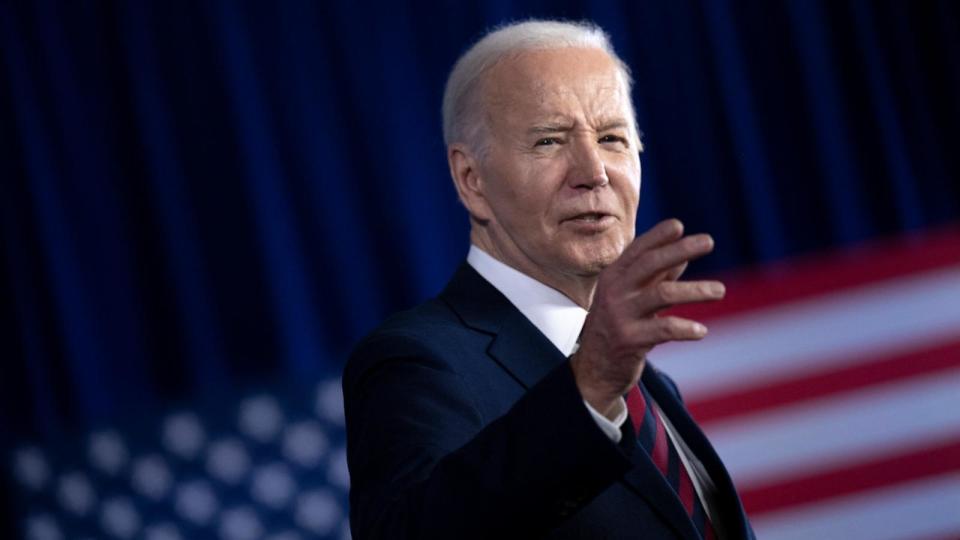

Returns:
467,245,716,523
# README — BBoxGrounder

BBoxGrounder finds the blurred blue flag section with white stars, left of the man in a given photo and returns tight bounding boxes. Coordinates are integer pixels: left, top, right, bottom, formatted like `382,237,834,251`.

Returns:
9,379,350,540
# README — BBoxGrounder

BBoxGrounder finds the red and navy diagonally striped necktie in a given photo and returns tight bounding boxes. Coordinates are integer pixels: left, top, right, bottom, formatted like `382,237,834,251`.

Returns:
627,384,716,540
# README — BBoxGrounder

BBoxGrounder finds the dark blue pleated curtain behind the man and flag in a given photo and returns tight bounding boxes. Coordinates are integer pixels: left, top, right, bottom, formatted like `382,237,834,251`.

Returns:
0,0,960,528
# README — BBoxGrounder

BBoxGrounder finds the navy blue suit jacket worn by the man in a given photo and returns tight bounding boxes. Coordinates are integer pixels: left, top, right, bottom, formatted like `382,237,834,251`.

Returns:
343,264,753,540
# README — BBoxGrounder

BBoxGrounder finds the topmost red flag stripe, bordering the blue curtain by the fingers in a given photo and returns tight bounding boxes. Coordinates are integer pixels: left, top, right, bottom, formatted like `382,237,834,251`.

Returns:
667,225,960,321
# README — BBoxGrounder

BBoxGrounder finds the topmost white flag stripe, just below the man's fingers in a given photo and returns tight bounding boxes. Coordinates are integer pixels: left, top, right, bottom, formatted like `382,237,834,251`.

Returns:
651,266,960,400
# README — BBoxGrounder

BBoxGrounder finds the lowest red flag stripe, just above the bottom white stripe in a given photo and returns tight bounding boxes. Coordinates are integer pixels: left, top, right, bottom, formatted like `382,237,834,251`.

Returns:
739,438,960,516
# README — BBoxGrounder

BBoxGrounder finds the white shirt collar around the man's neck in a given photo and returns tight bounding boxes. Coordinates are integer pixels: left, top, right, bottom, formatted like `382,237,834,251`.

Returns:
467,245,587,356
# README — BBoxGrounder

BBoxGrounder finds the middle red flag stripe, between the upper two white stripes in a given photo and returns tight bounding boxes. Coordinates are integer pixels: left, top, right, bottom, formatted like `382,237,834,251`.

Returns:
687,341,960,426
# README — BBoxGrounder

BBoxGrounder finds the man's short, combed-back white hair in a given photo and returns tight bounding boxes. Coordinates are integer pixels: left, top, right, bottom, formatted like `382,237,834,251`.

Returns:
443,20,637,152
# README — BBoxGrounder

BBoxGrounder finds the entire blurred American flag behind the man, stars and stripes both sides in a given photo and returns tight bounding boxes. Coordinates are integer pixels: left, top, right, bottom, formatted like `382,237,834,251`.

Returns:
9,228,960,540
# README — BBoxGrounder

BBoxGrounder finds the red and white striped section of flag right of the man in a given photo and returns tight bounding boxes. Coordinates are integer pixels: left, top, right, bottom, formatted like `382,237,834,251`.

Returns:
651,227,960,540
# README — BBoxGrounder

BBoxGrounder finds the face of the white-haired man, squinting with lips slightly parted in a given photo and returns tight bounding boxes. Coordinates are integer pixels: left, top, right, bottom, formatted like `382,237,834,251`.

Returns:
478,48,640,282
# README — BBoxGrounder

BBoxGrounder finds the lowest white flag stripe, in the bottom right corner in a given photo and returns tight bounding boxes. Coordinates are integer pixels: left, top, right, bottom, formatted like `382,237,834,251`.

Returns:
750,473,960,540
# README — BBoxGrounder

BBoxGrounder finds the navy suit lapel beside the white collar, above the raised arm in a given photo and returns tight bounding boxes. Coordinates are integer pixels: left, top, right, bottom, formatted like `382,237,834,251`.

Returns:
440,263,566,388
